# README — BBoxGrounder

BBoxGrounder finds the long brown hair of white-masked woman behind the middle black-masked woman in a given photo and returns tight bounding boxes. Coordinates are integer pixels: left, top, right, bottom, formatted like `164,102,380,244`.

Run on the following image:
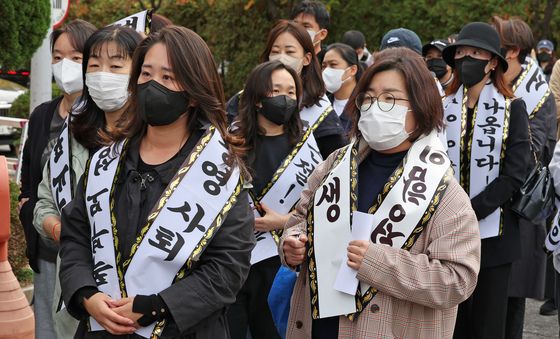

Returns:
261,20,325,107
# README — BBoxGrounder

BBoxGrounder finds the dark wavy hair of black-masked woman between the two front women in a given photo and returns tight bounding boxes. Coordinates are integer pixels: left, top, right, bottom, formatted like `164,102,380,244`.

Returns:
233,60,303,163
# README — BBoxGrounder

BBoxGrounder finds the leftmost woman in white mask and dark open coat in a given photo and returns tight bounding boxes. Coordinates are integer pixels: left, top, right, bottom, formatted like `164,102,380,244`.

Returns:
19,20,96,339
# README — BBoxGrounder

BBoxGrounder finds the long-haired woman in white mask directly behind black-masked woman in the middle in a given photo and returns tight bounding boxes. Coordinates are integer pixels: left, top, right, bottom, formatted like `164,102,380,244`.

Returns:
227,20,347,158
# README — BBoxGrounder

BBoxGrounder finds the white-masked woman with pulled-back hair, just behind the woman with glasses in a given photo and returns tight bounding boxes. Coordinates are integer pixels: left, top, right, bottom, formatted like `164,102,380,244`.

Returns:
323,43,363,131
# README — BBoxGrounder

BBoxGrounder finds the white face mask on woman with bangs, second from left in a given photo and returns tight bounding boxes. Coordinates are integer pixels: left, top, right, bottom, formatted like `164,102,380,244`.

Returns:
86,72,129,112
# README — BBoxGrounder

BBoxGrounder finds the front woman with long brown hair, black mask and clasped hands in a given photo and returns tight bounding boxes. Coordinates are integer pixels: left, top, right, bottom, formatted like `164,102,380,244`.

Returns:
60,26,255,338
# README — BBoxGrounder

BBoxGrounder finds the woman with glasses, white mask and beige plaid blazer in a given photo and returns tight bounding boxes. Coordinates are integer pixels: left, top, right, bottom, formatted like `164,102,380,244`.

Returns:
279,48,480,339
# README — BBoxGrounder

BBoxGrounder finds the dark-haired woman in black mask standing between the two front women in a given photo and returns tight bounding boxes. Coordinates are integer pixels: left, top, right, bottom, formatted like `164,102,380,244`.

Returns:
228,61,306,339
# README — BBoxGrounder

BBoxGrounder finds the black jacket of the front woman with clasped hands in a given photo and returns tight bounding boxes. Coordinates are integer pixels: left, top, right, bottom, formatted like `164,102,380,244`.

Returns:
60,134,255,339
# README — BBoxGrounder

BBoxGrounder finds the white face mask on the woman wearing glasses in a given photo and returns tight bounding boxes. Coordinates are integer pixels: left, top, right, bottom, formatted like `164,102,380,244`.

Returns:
358,101,410,151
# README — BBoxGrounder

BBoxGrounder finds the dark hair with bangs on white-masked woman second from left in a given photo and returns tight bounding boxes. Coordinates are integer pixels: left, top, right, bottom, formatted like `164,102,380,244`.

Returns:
71,26,142,149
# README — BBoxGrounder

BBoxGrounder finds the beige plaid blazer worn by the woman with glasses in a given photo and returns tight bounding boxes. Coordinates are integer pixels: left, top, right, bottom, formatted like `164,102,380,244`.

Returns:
279,142,481,339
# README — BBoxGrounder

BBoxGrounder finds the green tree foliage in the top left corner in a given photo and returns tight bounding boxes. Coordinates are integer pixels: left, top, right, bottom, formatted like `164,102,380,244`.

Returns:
0,0,51,67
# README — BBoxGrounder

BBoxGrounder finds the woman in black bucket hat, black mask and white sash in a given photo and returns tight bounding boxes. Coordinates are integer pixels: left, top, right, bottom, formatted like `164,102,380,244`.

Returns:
443,22,530,339
